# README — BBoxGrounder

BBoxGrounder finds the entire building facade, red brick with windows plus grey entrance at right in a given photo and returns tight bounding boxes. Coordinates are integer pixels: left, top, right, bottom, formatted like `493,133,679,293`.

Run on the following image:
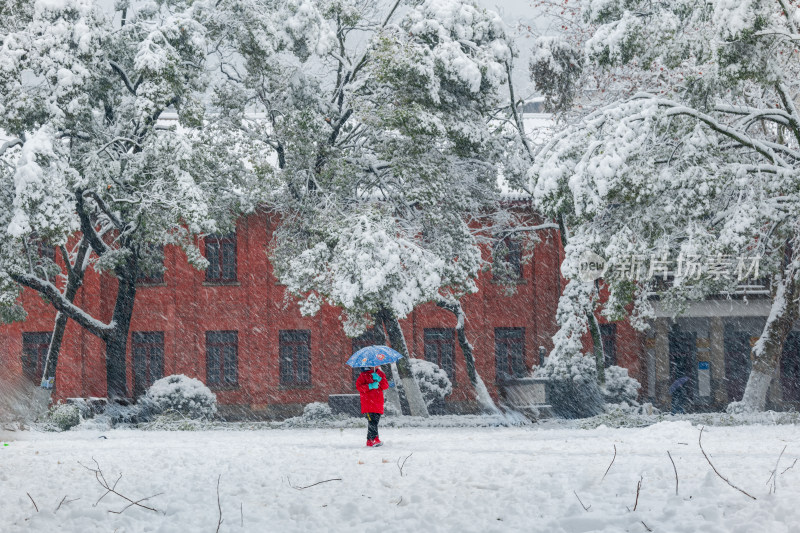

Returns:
7,206,800,418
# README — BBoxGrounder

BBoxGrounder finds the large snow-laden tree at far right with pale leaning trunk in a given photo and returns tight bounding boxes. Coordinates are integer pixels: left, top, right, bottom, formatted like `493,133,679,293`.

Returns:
531,0,800,409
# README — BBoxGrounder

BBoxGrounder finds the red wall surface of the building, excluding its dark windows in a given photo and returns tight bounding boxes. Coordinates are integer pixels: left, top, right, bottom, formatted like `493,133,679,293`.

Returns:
0,209,576,409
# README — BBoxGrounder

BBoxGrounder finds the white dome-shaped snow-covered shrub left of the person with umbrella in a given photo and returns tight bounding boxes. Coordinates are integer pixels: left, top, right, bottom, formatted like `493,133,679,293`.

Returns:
139,374,217,419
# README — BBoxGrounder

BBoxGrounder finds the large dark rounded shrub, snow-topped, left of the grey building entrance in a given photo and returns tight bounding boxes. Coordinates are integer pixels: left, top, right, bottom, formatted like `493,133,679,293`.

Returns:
533,353,603,418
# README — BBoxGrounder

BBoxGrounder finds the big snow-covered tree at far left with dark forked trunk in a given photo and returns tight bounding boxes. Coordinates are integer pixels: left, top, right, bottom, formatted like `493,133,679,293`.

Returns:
0,0,259,396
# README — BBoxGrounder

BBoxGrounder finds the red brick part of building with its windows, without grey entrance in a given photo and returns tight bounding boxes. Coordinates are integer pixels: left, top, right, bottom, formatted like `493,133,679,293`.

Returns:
0,208,642,417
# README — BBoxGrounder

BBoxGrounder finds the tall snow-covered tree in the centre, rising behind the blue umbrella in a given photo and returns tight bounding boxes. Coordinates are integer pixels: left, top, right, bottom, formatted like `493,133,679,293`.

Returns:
203,0,512,414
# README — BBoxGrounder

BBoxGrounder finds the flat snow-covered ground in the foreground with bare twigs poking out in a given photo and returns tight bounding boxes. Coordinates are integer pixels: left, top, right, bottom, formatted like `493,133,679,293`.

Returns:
0,421,800,533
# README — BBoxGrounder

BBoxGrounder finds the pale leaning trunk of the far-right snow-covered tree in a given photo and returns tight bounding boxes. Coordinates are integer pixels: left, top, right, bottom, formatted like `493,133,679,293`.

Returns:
729,266,800,411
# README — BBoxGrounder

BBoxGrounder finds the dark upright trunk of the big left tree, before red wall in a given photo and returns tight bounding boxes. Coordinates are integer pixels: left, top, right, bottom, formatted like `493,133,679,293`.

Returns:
106,259,137,398
